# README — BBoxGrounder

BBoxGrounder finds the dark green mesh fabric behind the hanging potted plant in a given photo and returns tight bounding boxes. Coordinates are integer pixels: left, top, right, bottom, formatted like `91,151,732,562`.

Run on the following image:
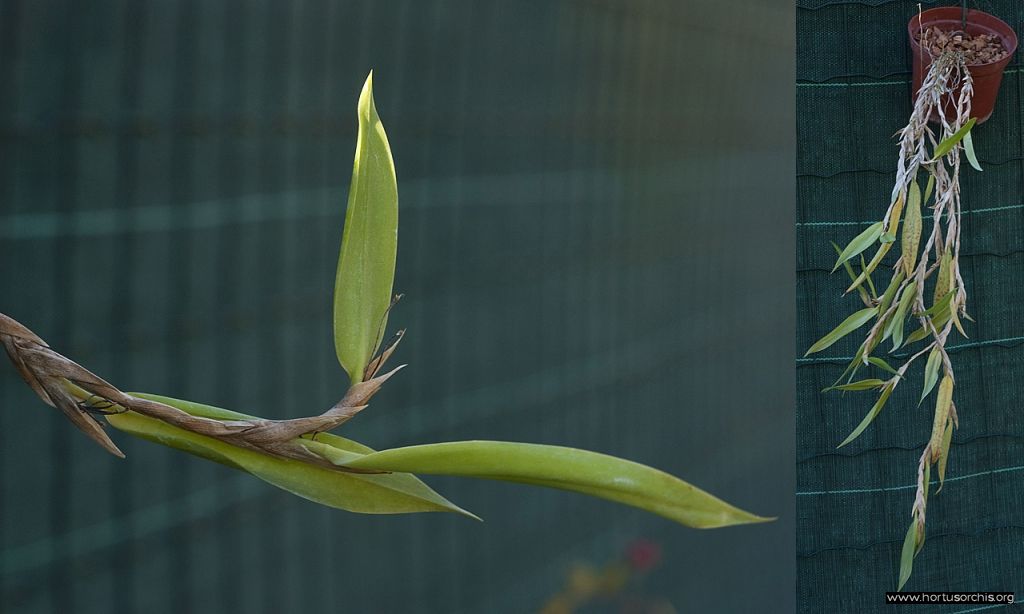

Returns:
797,0,1024,612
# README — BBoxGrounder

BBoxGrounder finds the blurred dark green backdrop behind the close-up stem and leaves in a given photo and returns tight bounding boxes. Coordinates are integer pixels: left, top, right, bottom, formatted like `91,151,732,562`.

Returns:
0,0,794,613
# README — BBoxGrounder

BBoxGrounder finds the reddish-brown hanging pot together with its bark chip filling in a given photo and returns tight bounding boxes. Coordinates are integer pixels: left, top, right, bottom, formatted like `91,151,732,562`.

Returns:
907,6,1017,124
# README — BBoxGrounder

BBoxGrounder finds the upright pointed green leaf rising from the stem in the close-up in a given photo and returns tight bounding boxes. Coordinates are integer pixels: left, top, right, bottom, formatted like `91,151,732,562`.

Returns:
334,73,398,384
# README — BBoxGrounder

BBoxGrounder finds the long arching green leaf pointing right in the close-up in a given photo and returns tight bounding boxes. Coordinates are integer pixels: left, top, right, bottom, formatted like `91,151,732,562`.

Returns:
339,441,772,528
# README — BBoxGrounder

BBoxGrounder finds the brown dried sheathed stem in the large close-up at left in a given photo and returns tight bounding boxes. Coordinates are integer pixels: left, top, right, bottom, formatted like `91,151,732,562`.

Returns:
0,313,403,473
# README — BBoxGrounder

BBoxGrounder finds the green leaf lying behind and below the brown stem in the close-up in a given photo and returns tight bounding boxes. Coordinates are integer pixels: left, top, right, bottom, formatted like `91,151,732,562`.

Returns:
106,393,476,518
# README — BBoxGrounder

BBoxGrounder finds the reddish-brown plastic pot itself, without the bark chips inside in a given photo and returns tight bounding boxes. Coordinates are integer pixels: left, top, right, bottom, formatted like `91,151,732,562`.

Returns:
907,6,1017,124
